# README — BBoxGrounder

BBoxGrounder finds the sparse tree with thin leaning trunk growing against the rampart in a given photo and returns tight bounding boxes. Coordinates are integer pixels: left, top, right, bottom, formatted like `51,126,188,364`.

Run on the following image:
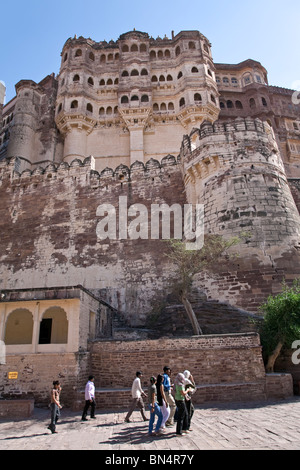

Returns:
167,235,240,335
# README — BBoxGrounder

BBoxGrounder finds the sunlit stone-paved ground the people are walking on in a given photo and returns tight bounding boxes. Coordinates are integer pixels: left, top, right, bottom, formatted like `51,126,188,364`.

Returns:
0,397,300,452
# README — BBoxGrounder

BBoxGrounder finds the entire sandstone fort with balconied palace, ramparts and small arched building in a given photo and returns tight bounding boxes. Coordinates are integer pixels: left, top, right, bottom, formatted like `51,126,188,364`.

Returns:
0,30,300,401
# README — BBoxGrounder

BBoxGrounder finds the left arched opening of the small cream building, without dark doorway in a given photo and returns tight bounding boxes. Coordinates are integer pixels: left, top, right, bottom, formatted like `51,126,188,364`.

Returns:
4,308,33,344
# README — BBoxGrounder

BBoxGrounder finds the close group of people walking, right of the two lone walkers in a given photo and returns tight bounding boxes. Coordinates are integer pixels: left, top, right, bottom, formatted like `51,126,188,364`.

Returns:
125,366,196,436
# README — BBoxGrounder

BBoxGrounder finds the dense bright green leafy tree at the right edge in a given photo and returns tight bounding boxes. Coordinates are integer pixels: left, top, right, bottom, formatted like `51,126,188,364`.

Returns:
260,280,300,373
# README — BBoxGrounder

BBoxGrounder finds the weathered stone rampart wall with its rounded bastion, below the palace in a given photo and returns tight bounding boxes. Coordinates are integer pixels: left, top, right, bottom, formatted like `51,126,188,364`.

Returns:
0,119,300,331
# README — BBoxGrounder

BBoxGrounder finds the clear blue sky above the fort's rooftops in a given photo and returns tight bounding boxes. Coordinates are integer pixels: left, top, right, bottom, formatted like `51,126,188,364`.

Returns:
0,0,300,102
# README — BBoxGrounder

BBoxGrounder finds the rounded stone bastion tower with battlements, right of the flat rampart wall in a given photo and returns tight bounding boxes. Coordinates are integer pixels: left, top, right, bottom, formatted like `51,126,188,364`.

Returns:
180,118,300,310
